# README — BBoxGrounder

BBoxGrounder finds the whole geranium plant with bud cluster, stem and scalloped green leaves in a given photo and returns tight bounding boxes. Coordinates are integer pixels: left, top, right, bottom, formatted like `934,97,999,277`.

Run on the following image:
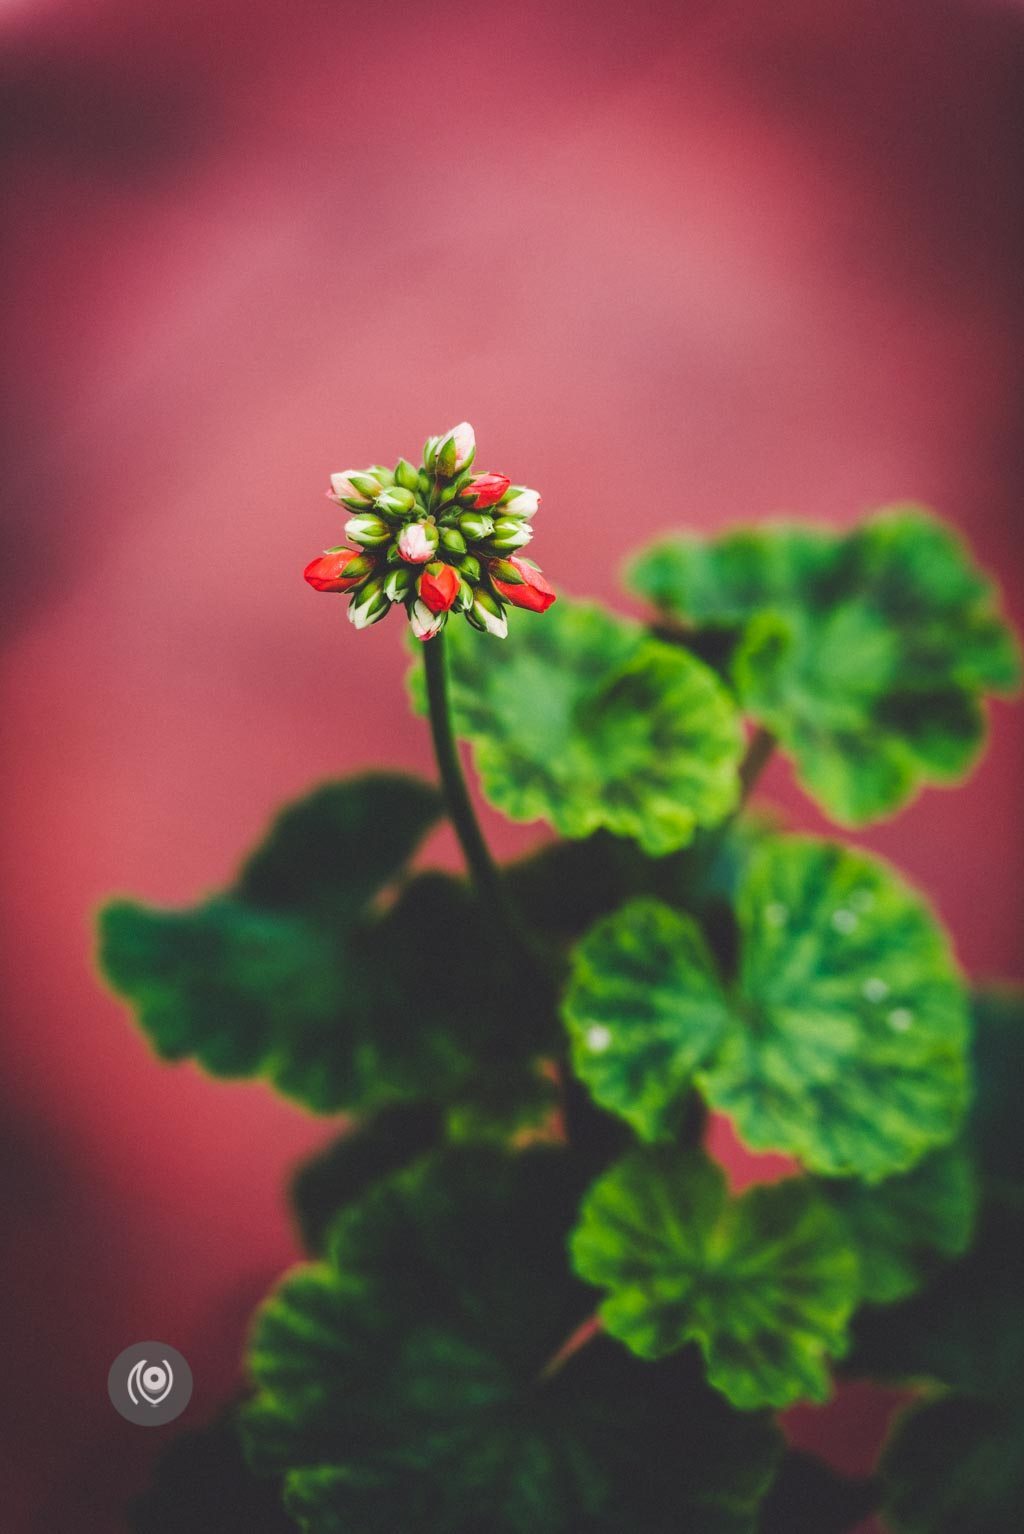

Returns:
101,423,1024,1534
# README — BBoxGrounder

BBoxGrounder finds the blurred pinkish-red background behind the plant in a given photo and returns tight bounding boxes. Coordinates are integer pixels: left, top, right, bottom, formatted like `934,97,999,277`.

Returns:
0,0,1024,1534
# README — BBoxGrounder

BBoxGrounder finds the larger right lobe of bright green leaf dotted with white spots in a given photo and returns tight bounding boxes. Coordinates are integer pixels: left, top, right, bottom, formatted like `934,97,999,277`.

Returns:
697,838,969,1181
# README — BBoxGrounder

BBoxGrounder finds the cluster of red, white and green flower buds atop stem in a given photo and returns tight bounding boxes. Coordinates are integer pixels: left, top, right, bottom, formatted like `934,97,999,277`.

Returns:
305,420,555,640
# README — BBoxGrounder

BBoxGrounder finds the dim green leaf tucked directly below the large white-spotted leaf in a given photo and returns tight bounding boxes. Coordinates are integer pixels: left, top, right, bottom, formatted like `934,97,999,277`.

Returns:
819,1144,976,1305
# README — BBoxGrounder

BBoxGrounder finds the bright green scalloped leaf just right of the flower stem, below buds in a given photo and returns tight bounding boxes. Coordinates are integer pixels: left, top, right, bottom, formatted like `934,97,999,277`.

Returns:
412,600,743,856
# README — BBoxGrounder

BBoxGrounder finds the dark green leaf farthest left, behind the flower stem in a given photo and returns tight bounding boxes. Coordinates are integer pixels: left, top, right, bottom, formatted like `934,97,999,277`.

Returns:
100,776,547,1112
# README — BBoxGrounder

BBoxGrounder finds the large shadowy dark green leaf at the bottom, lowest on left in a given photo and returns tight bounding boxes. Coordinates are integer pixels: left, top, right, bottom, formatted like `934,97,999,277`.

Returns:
245,1149,779,1534
